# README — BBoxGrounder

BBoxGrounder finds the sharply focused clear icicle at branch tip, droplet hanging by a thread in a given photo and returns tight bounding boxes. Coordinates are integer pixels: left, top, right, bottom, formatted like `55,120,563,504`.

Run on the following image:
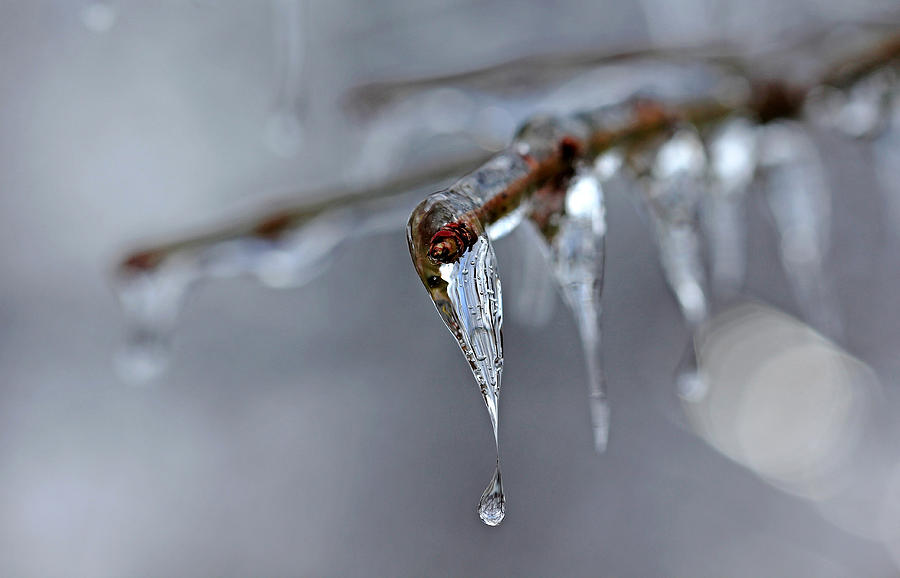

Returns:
407,192,506,526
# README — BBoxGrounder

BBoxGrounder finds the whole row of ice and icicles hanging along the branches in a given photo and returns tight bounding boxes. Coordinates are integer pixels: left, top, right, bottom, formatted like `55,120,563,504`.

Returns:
117,46,900,526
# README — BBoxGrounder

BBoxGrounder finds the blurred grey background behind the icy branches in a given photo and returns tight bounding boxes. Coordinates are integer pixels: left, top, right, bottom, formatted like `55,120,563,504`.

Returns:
0,0,900,577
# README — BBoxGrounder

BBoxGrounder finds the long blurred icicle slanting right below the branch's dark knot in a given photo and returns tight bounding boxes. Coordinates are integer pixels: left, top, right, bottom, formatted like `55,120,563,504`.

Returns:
760,122,842,339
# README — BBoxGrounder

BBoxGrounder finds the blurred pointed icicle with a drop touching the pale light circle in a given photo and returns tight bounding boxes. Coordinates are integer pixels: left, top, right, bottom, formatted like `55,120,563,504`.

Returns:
644,128,709,399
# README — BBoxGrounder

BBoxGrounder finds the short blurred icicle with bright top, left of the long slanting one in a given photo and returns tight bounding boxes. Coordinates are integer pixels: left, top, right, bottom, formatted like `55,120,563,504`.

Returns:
700,118,757,297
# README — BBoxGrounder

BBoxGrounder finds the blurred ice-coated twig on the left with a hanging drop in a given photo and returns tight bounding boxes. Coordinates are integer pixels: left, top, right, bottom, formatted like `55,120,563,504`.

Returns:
113,195,412,384
